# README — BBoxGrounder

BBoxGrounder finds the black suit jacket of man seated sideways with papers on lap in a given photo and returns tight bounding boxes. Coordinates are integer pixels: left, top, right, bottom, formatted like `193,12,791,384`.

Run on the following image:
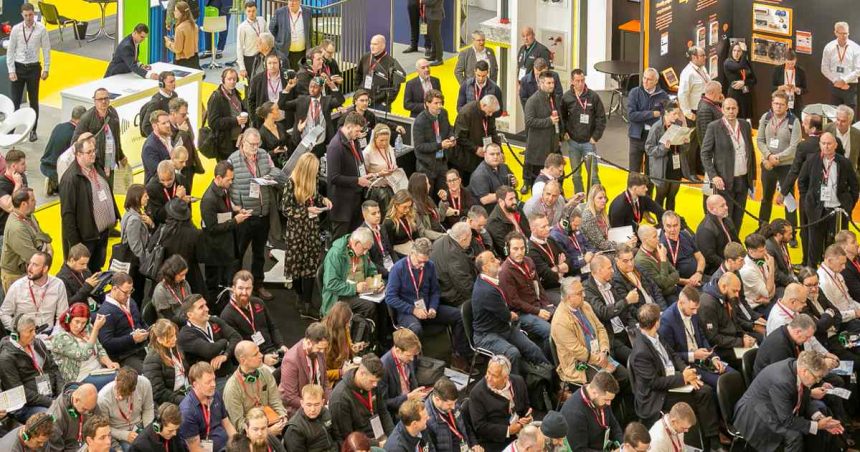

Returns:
630,332,686,419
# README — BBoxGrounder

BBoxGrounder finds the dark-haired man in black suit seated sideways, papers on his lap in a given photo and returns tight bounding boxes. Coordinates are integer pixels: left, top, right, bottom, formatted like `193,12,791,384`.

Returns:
630,304,722,451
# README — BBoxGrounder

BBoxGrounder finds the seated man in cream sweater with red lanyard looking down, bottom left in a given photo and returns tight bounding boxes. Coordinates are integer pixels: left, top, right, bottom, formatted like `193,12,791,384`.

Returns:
99,367,155,451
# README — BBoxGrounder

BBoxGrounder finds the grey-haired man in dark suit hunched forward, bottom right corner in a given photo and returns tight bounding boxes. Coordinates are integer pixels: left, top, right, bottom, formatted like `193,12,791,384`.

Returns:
732,351,844,452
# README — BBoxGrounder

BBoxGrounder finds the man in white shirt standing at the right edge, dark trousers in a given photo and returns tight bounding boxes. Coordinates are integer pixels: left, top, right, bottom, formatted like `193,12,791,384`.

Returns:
821,22,860,114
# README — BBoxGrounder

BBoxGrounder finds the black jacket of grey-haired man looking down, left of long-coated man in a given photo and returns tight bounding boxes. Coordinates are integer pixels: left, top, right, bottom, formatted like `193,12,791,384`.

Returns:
448,101,502,173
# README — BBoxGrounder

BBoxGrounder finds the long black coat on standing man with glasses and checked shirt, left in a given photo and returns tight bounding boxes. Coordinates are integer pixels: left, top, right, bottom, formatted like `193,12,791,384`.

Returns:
60,163,120,254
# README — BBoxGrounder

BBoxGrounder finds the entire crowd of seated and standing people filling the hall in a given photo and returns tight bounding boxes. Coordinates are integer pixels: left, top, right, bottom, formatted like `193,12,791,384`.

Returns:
5,0,860,452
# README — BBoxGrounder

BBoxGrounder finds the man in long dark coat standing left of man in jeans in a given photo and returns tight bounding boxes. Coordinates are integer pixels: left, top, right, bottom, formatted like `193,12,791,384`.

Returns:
520,71,564,194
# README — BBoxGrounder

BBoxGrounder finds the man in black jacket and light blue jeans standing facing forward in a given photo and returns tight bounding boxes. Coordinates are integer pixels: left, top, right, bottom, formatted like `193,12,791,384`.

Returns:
556,69,606,193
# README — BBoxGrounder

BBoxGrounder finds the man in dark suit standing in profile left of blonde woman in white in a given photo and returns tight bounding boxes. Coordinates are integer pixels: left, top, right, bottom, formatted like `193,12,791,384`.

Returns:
326,111,371,240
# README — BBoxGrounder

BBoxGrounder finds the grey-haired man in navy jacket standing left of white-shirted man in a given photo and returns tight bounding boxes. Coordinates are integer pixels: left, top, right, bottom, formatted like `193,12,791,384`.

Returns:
627,67,669,177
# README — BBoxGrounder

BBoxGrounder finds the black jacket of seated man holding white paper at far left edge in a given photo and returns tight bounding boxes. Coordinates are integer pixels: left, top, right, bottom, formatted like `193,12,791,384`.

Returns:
0,337,65,408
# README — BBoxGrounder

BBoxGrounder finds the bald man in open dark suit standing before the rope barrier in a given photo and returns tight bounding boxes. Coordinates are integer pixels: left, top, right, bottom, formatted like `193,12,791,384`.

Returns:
702,98,756,230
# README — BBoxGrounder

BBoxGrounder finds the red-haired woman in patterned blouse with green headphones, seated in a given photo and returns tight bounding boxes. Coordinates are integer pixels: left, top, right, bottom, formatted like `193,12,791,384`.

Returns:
51,303,119,389
